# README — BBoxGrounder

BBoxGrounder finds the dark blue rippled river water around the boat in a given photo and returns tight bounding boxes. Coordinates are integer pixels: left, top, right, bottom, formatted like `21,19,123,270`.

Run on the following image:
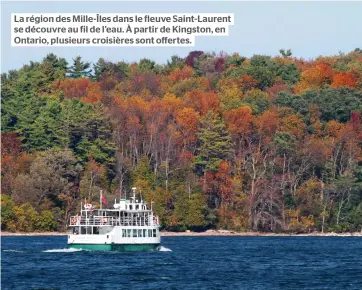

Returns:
1,237,362,290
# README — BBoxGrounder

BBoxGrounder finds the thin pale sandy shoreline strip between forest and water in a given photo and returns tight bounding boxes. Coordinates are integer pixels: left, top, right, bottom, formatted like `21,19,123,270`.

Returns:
0,230,362,237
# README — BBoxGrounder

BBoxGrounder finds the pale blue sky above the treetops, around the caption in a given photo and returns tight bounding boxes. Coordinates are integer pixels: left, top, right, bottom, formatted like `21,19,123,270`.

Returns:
1,1,362,72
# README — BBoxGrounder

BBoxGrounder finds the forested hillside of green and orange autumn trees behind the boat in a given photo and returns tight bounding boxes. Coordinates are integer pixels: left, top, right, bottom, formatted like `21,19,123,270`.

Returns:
1,49,362,233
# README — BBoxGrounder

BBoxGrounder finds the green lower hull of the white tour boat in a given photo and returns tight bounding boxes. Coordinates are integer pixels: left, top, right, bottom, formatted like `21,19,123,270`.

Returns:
68,244,159,252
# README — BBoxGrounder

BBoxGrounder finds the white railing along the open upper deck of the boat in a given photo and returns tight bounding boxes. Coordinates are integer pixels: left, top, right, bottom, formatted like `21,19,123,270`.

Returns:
70,216,154,226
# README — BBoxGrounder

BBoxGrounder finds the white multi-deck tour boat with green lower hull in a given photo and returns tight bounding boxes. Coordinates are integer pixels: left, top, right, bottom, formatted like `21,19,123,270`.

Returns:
68,187,161,251
